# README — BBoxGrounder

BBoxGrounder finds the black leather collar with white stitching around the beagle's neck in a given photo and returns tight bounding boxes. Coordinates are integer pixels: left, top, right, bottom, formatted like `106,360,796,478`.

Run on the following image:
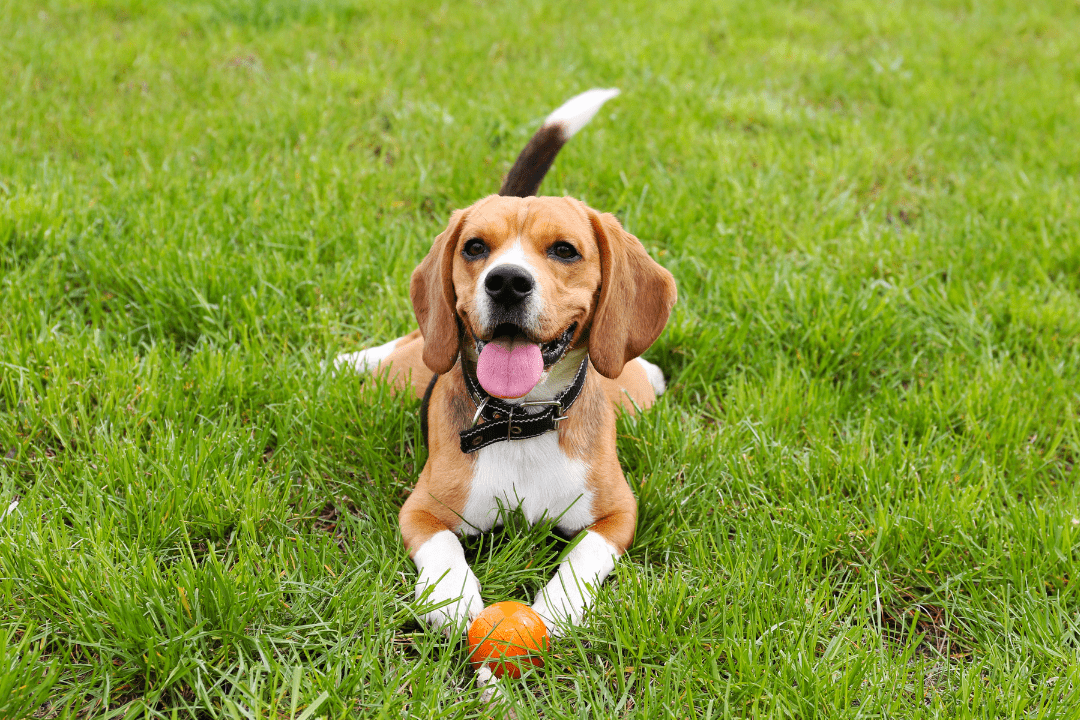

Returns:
460,355,589,454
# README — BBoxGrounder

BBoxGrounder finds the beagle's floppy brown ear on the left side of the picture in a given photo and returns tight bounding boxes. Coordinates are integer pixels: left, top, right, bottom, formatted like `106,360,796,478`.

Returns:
408,210,465,373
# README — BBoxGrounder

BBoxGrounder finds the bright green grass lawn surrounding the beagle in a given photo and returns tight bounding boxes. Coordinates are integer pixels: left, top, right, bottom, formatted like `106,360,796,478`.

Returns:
0,0,1080,719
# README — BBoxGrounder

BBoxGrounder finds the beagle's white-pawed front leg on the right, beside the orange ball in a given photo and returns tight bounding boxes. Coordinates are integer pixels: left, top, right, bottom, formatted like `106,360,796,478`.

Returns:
532,513,636,637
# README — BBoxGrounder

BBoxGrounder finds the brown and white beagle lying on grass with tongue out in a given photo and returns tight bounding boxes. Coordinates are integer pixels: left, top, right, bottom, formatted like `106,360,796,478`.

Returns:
336,90,676,635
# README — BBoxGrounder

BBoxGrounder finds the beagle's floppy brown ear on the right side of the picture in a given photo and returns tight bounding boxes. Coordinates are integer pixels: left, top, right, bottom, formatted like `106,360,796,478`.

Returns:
589,210,678,379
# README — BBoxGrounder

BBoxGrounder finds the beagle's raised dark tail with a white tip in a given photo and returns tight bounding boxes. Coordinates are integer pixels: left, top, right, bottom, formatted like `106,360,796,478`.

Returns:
499,87,619,198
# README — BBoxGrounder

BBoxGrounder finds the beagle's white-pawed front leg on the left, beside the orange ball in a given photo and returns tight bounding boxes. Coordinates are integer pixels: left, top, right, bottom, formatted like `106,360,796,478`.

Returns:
399,505,484,637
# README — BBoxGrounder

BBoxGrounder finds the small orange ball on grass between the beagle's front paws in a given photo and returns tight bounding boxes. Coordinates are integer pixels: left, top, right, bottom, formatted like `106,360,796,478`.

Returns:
469,600,548,678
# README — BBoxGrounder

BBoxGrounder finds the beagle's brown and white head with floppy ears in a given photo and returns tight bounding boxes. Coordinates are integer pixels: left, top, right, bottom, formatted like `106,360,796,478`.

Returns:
409,195,676,390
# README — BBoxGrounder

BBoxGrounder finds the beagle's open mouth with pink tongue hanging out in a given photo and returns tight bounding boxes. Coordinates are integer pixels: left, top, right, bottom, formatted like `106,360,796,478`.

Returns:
475,323,578,398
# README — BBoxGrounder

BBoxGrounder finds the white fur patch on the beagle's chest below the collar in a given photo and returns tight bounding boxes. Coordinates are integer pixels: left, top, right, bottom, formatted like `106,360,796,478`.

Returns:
461,433,594,534
